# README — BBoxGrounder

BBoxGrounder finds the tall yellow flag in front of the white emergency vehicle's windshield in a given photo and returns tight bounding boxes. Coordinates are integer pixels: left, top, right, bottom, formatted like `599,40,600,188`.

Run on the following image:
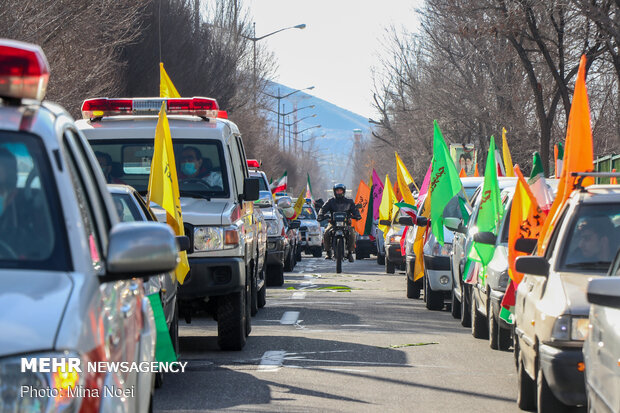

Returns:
147,102,189,284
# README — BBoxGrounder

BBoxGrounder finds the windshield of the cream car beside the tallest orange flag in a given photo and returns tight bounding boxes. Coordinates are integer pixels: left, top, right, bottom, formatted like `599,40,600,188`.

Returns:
559,203,620,272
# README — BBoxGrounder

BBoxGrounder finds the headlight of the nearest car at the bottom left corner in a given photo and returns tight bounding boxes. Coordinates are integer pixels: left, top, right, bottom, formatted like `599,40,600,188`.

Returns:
0,353,86,413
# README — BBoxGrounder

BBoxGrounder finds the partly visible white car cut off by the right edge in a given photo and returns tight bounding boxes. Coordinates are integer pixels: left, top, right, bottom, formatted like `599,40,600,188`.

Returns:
583,254,620,412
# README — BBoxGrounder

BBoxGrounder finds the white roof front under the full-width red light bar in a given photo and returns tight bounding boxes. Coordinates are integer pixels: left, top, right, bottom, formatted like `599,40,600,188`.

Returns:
75,115,239,140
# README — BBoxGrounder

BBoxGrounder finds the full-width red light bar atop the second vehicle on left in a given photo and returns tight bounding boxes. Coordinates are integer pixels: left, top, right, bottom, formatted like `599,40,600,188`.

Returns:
82,97,220,119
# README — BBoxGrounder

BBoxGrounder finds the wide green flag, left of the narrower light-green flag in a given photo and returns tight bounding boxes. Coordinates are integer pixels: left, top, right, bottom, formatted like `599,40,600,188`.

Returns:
429,120,463,245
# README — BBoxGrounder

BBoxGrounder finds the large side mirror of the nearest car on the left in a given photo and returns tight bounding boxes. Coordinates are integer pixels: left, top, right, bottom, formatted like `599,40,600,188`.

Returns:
105,222,179,282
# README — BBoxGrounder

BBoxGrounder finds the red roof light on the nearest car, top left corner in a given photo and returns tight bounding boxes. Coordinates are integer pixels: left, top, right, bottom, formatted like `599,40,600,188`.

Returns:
0,39,50,101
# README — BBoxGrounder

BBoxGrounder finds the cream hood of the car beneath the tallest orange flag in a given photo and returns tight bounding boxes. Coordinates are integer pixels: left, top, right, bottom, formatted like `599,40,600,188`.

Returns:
545,272,602,316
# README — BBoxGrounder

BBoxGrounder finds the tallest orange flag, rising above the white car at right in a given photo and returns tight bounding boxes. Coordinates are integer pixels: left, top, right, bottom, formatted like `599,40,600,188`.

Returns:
538,55,594,255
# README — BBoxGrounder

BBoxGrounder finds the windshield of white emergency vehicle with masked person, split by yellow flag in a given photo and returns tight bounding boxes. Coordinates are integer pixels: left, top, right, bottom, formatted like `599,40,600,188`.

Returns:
90,139,229,198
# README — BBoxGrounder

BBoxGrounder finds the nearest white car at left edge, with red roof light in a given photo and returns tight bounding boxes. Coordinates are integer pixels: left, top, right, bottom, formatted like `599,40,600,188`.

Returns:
0,40,178,412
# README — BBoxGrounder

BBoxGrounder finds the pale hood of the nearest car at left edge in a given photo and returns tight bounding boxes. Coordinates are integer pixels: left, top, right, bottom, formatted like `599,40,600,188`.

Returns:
0,269,73,357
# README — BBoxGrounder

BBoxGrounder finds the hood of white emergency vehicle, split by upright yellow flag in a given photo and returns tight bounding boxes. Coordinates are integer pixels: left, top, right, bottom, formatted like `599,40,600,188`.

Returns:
151,197,229,225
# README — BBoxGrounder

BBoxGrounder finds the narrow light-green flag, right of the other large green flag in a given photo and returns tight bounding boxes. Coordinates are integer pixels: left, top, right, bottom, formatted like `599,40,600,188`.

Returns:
474,136,503,267
